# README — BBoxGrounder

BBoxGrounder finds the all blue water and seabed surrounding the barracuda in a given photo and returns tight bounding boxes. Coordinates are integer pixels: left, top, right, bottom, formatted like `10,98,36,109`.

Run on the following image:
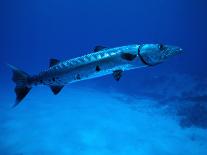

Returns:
0,0,207,155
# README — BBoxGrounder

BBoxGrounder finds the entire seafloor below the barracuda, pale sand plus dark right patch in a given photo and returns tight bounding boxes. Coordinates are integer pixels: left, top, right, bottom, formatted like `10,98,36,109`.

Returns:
0,75,207,155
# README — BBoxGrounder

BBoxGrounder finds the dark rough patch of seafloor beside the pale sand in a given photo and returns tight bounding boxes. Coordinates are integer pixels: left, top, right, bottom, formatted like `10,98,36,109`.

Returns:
116,75,207,129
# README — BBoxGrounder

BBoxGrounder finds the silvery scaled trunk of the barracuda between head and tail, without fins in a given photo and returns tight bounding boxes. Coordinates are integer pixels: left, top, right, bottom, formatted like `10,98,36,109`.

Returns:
34,45,146,86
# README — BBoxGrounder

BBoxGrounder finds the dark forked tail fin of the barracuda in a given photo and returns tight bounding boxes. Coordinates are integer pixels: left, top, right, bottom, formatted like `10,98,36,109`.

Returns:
8,64,31,107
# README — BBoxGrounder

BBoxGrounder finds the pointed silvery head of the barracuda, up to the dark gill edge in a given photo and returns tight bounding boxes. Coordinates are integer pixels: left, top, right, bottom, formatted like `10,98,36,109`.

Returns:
139,44,183,66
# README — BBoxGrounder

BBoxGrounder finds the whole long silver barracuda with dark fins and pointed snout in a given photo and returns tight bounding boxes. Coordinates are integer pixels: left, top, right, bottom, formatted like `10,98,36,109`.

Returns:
9,44,183,106
